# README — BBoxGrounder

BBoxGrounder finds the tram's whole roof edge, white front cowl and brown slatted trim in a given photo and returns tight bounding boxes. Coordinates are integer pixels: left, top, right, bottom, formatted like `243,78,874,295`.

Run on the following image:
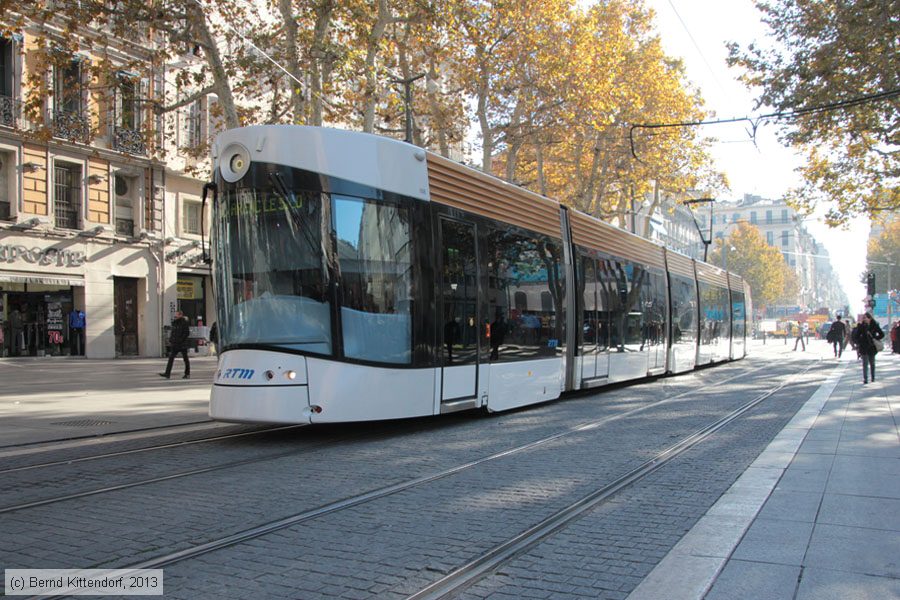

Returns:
212,125,728,287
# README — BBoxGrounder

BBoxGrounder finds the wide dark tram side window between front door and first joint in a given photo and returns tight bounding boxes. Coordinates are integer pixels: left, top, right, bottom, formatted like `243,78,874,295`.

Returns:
488,230,565,361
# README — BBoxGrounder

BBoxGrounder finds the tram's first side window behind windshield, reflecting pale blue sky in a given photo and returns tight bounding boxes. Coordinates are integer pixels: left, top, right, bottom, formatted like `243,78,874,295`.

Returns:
333,196,413,364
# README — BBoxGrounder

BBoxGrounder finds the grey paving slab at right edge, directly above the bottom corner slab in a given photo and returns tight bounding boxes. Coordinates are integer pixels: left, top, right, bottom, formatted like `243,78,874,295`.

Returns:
804,524,900,578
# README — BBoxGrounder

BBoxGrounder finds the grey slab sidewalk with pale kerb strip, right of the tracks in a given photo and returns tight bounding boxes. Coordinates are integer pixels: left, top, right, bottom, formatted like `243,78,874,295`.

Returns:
628,346,900,600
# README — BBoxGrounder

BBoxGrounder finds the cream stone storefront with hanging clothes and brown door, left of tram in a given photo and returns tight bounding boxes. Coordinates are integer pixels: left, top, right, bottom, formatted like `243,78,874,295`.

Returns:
0,231,165,358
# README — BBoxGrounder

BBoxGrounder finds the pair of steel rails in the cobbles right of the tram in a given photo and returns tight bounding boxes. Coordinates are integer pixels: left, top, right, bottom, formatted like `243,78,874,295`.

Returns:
37,358,815,598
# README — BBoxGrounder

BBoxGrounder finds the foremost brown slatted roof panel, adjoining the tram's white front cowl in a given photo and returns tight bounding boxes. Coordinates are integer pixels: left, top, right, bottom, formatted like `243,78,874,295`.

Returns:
428,153,561,239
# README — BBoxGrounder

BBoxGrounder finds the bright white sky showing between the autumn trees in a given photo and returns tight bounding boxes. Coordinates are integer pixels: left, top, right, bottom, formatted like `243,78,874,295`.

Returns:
645,0,869,313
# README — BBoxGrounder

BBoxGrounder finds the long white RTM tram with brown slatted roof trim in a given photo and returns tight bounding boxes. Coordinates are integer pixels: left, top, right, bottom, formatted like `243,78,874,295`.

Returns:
204,125,751,423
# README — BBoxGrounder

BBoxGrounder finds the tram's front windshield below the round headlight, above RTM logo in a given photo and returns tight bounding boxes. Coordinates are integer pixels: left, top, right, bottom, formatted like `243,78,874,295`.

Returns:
214,168,332,354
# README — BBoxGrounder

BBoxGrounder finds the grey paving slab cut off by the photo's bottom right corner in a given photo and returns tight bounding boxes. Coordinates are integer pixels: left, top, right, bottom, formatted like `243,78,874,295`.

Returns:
796,568,900,600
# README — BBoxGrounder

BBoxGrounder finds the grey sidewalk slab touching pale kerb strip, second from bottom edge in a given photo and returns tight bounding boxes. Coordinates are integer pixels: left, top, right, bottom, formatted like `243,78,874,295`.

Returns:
732,518,813,567
